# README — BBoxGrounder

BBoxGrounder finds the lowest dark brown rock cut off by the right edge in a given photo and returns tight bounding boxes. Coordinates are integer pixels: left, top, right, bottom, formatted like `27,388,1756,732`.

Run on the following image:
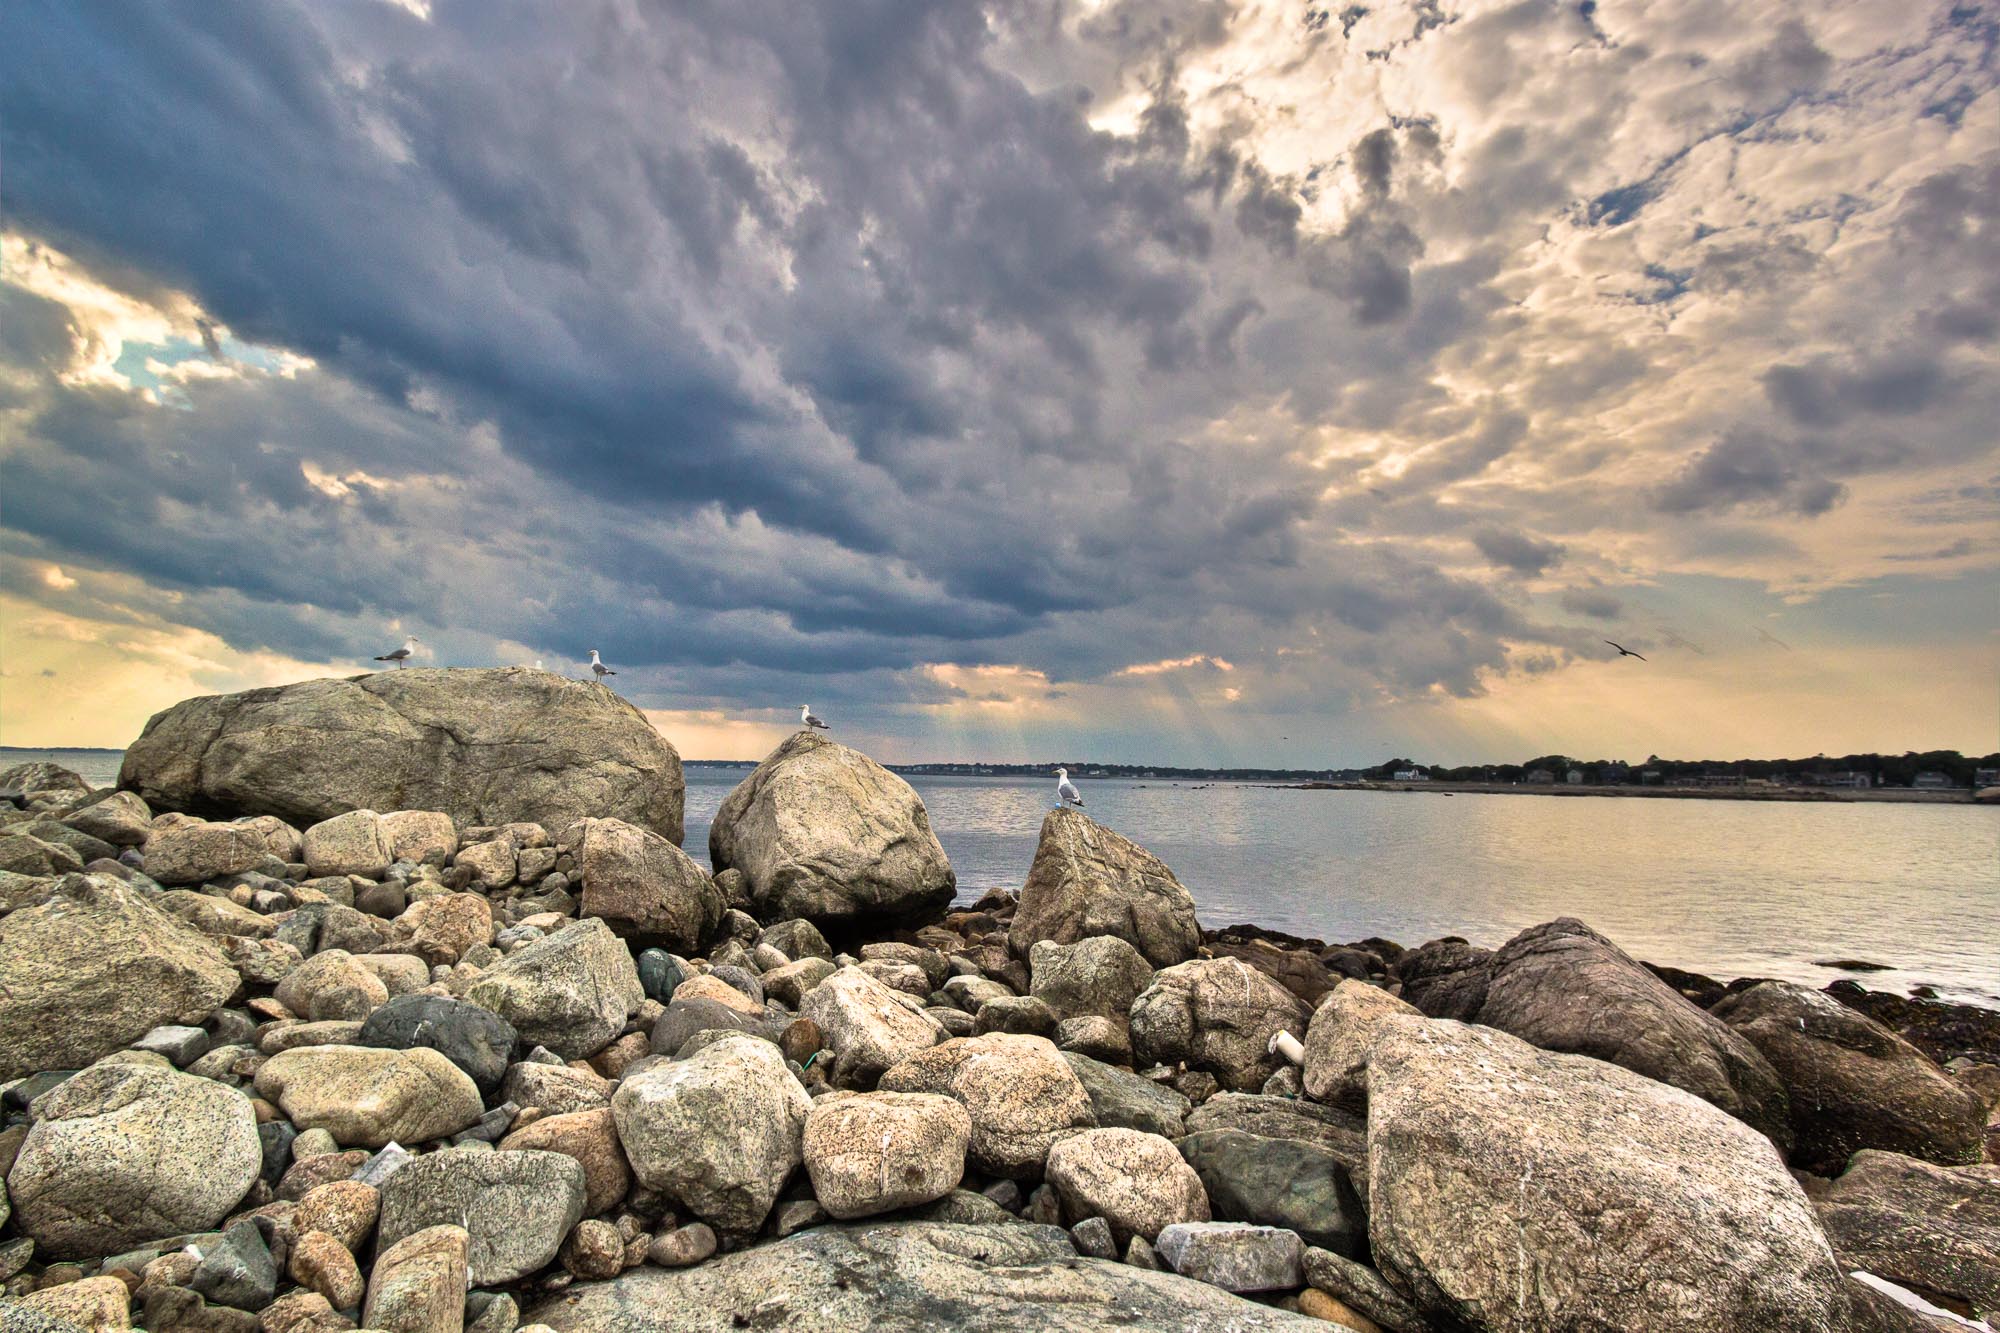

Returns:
1812,1149,2000,1317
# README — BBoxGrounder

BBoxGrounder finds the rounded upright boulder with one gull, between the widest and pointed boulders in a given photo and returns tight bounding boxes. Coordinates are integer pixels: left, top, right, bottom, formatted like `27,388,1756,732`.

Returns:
708,731,958,927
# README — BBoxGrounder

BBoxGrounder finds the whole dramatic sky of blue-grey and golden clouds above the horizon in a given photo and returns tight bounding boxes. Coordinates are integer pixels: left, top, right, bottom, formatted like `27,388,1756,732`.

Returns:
0,0,2000,767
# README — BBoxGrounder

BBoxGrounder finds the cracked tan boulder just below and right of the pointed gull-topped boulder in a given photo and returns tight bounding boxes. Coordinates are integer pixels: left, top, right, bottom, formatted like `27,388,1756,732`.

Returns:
1132,959,1312,1093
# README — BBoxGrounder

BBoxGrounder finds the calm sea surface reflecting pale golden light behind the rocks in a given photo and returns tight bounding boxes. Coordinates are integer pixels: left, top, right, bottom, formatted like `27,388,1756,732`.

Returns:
0,751,2000,1005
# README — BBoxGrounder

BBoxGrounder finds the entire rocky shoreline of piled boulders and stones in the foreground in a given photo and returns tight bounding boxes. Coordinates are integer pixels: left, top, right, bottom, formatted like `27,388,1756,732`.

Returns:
0,671,2000,1333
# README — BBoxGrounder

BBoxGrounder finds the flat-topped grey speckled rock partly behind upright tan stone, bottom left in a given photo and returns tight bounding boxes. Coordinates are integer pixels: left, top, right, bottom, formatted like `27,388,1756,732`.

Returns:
376,1149,584,1287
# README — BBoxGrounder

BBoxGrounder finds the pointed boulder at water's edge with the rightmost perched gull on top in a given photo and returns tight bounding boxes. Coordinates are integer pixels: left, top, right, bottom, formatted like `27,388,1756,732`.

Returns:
1008,809,1202,967
